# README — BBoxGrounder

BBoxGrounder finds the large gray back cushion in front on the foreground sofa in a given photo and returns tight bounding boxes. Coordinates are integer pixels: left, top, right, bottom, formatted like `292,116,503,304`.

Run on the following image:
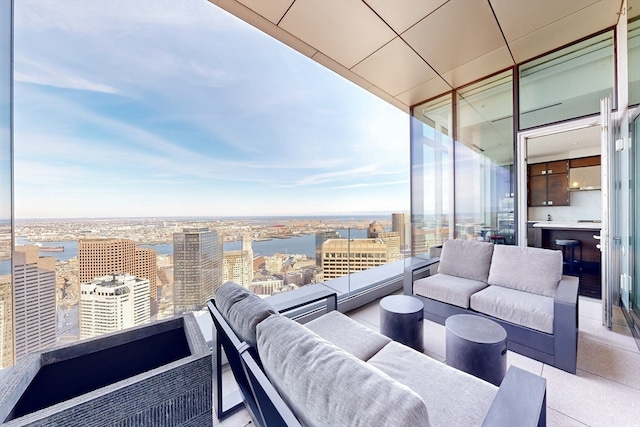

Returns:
257,316,429,427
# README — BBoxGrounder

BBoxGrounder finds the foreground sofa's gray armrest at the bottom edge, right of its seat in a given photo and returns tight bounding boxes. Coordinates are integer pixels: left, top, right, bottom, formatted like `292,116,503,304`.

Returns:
482,366,547,427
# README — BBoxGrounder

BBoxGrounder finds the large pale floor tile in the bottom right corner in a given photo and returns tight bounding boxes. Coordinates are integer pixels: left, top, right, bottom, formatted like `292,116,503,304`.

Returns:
542,365,640,426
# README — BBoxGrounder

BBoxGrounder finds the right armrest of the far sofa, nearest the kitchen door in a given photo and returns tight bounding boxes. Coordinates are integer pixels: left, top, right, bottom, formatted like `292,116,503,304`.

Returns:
553,276,579,374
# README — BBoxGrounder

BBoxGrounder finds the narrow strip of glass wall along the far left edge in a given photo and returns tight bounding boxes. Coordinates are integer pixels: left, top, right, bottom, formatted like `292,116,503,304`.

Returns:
0,1,13,368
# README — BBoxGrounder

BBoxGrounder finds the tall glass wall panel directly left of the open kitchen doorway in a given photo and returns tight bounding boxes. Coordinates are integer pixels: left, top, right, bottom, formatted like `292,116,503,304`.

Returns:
454,70,515,244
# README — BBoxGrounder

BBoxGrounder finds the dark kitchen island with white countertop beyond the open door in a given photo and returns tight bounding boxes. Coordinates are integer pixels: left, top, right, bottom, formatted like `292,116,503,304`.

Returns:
533,221,602,298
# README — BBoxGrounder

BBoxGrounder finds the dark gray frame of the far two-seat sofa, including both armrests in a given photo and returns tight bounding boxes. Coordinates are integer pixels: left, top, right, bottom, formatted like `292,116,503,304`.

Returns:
403,258,578,374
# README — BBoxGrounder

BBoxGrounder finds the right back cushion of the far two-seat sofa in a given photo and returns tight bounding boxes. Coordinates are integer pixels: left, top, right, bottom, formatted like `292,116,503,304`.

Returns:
488,245,562,297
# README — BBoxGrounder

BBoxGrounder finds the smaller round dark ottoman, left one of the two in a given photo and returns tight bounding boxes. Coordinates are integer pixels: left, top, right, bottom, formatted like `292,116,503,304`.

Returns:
380,295,424,352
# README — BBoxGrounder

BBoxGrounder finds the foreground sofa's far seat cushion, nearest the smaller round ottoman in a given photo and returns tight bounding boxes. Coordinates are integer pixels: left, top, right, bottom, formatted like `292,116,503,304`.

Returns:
305,311,391,362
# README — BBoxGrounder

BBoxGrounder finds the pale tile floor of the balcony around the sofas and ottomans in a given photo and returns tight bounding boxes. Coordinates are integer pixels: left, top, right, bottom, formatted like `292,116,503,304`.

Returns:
214,297,640,427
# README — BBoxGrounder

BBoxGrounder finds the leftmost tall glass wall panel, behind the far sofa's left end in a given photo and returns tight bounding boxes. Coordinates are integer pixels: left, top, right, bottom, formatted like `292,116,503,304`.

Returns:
411,94,453,257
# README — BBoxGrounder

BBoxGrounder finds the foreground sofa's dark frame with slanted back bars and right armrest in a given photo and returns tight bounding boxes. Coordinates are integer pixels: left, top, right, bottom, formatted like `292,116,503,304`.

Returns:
207,290,547,427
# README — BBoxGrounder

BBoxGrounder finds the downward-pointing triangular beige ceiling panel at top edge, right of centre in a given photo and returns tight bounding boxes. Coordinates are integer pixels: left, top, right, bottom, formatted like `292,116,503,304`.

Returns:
364,0,447,34
